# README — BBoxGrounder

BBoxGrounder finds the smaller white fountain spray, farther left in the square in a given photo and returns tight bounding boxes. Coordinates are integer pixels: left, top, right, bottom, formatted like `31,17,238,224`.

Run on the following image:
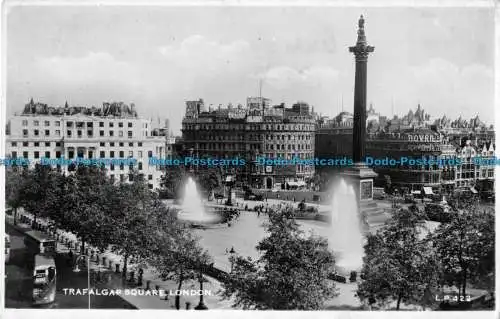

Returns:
177,177,220,224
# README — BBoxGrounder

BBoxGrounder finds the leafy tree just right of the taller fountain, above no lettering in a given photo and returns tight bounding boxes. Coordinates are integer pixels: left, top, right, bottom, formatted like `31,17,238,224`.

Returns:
357,206,437,310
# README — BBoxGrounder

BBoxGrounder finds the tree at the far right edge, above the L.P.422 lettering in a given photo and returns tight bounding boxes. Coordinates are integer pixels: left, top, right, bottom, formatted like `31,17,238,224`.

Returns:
430,201,495,298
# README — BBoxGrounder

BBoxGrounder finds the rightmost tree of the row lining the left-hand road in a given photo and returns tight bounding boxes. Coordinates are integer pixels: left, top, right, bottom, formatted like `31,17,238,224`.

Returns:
148,211,211,309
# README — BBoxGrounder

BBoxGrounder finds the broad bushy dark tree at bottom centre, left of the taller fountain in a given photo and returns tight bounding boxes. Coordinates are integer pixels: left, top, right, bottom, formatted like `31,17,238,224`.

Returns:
224,210,336,310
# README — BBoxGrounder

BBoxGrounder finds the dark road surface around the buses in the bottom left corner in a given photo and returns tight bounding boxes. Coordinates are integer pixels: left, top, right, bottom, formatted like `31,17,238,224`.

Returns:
5,224,134,309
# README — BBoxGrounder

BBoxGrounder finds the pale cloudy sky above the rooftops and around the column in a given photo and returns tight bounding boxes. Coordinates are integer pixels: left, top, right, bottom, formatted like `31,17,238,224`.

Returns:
6,6,494,132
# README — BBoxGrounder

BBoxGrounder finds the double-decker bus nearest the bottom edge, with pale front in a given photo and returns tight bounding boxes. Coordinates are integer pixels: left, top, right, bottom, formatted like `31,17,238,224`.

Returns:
33,255,57,305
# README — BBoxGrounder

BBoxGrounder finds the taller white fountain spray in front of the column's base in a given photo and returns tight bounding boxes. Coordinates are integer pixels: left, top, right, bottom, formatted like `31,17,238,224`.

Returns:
328,179,364,275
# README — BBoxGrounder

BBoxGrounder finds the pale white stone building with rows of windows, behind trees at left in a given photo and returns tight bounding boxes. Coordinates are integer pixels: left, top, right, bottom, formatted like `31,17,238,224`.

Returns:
5,100,167,189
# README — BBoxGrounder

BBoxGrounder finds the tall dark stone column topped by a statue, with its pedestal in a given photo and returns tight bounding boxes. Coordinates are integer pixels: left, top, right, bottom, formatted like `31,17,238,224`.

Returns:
342,16,377,217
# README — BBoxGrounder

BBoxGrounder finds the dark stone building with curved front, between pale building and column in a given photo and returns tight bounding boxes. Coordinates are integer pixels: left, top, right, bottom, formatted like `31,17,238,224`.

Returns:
182,97,316,188
